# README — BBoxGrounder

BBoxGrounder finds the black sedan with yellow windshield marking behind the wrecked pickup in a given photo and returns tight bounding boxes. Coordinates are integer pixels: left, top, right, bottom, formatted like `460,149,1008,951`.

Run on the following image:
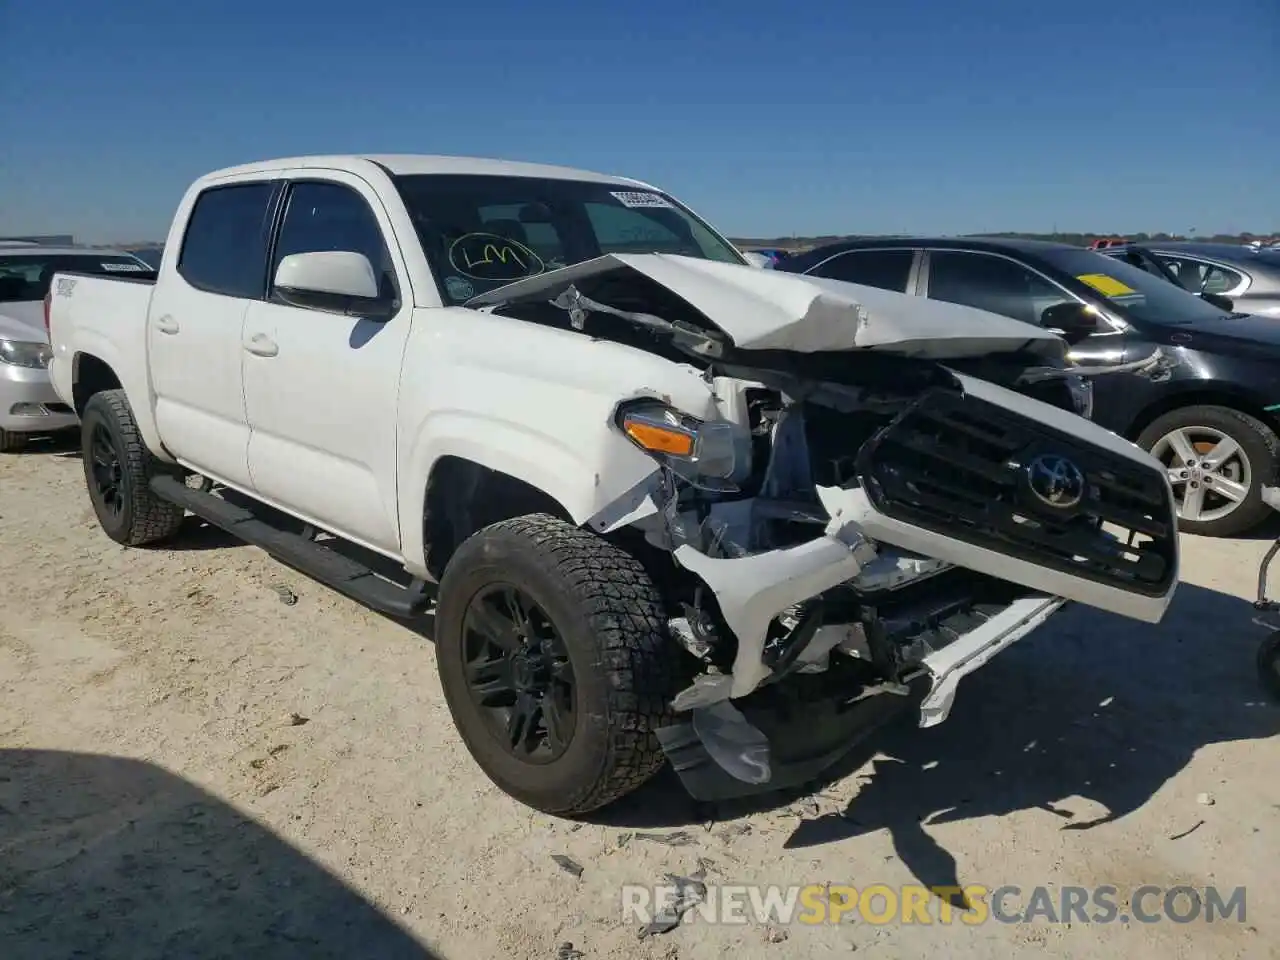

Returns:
776,237,1280,536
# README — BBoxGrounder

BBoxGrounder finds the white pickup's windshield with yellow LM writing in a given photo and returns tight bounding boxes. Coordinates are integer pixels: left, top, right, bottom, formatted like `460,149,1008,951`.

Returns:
396,174,744,303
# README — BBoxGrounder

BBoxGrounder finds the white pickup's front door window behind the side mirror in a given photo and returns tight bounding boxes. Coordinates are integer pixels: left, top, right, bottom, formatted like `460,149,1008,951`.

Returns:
271,180,394,298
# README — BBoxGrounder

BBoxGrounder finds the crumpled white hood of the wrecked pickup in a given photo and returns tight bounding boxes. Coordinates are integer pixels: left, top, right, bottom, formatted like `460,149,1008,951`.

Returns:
466,253,1064,360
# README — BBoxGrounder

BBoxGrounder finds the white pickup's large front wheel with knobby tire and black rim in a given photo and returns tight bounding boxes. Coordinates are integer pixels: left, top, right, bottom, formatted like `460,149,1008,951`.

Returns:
434,513,681,817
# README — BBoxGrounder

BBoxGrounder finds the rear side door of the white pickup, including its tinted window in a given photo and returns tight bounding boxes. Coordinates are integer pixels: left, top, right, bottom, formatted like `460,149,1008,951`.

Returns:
147,180,276,486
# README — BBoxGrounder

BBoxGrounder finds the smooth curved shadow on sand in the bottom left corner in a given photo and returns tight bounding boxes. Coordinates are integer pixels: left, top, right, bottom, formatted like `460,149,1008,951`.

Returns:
0,750,436,960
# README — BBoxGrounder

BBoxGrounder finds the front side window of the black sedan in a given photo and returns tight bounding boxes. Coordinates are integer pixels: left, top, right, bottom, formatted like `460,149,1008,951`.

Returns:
929,250,1075,325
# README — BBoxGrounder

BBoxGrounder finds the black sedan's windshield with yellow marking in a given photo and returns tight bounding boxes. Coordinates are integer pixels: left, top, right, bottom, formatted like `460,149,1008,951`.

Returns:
1042,250,1231,325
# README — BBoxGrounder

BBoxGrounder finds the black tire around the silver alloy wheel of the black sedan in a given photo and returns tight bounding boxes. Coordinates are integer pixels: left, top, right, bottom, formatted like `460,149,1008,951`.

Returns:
1137,406,1280,536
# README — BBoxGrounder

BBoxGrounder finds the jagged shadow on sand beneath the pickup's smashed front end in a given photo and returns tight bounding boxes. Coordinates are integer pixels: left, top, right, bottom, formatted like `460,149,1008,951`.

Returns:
588,584,1280,901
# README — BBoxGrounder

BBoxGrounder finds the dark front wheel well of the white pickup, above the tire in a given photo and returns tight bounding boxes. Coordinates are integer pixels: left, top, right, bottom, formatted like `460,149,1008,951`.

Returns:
422,457,572,579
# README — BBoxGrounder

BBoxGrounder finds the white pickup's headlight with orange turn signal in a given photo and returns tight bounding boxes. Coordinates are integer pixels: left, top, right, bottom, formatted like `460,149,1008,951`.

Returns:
618,402,750,493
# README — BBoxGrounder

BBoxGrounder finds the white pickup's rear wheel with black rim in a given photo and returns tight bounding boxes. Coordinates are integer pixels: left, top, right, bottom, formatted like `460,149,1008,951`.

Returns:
81,390,183,547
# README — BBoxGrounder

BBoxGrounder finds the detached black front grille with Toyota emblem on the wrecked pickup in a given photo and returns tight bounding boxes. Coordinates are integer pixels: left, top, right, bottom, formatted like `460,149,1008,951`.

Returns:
858,389,1178,596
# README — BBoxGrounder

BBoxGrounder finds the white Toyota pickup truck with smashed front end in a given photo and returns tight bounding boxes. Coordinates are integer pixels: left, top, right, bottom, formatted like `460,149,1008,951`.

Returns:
47,156,1179,815
